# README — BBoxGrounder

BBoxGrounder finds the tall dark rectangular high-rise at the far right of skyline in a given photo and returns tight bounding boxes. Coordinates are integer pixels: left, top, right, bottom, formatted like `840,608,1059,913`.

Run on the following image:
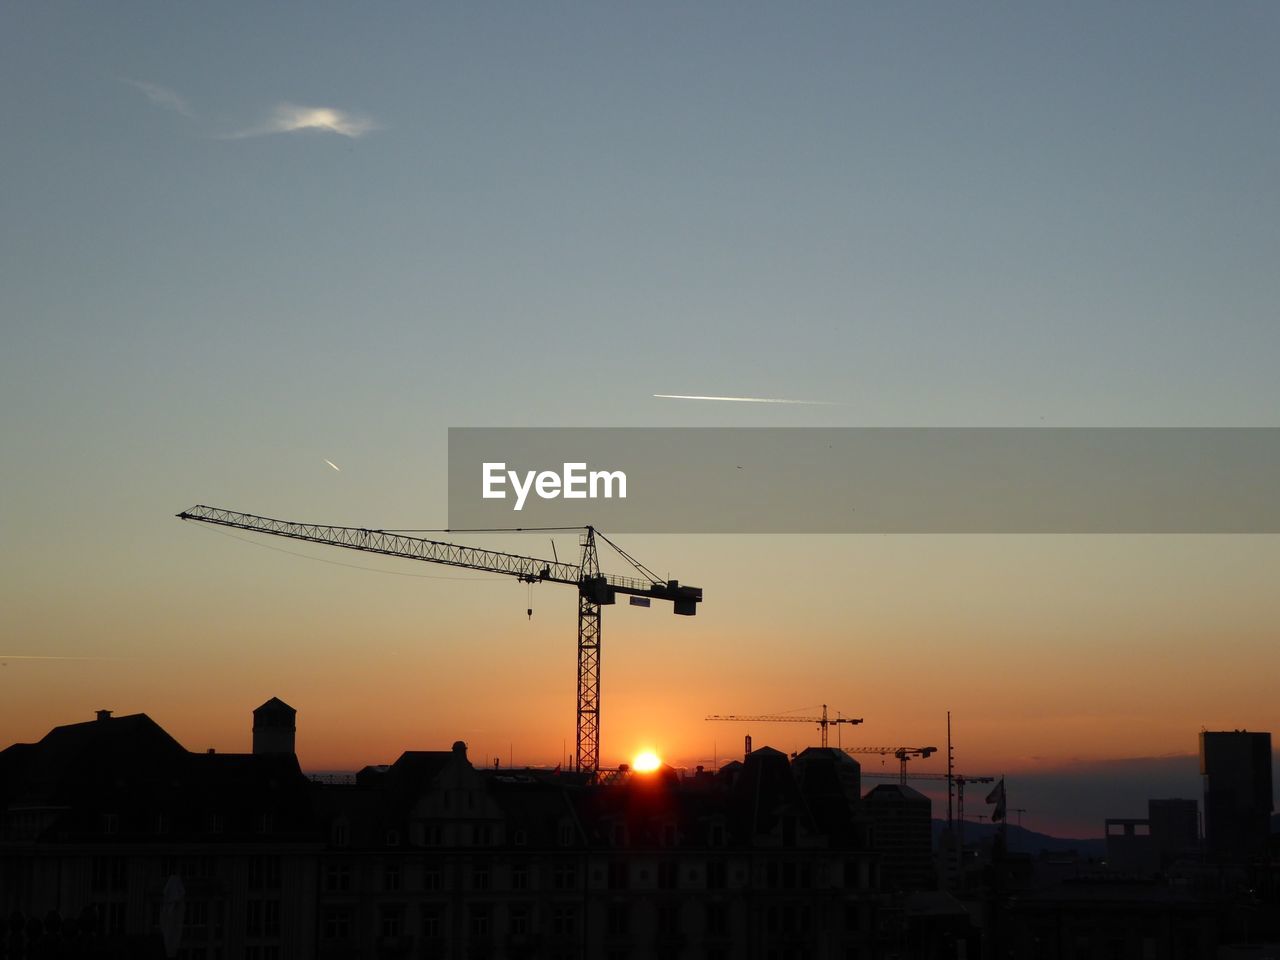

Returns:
1201,730,1274,860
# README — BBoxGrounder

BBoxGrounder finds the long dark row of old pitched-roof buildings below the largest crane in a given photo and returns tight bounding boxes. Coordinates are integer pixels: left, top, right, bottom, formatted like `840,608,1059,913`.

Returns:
0,699,887,960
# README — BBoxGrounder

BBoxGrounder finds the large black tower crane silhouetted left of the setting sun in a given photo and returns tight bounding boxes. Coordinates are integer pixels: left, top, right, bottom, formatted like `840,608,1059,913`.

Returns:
177,504,703,776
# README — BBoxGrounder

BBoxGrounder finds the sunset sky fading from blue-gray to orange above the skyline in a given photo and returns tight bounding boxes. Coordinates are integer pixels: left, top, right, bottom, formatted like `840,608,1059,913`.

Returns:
0,3,1280,835
